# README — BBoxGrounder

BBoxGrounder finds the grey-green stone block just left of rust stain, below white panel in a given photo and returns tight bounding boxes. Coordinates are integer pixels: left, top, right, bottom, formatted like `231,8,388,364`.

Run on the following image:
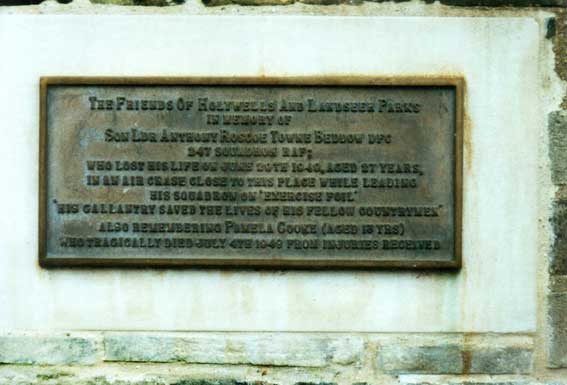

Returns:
378,344,463,374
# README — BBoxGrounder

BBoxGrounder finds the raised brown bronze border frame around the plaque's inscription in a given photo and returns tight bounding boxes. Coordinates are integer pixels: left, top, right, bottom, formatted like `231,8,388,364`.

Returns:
38,75,466,270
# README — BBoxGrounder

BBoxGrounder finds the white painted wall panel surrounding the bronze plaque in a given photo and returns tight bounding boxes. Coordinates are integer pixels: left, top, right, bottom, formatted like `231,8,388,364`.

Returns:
0,15,545,332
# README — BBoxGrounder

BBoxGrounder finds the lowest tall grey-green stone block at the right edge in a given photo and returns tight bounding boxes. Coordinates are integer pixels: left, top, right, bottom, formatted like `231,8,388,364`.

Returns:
548,293,567,368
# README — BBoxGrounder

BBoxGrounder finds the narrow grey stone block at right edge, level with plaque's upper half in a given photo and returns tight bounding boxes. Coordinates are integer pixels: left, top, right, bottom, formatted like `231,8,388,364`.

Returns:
548,111,567,184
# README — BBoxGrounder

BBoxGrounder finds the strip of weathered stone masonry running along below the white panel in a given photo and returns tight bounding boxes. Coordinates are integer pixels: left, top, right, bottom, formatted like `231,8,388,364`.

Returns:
0,332,534,385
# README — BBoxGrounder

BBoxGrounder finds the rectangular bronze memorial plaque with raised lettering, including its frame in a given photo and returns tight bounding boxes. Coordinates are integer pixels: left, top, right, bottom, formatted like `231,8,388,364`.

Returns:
39,78,463,268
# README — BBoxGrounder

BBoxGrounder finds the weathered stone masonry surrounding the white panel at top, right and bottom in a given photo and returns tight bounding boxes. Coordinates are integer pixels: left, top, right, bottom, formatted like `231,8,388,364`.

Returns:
0,0,567,385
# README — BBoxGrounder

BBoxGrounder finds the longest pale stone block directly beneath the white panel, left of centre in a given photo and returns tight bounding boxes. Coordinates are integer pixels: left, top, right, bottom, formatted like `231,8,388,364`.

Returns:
104,333,364,367
